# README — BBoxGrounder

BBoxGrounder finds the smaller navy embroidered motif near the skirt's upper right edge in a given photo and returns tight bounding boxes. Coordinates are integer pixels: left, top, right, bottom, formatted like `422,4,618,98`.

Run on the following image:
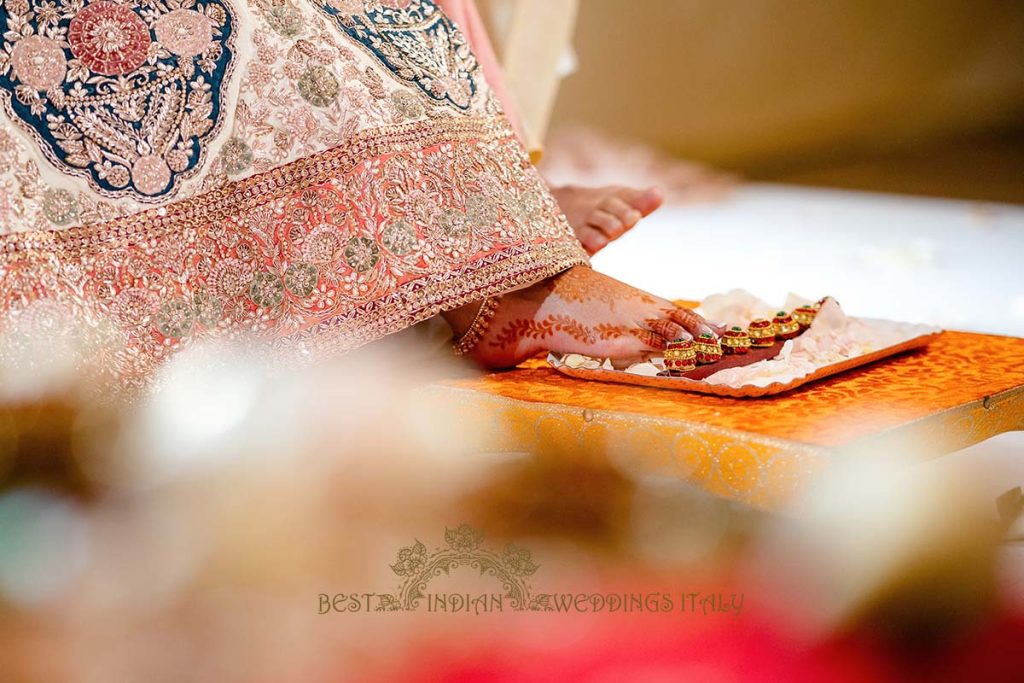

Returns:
310,0,480,112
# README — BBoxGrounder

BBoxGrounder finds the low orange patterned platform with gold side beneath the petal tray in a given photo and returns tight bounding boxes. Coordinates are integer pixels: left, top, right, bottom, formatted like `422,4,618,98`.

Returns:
437,332,1024,507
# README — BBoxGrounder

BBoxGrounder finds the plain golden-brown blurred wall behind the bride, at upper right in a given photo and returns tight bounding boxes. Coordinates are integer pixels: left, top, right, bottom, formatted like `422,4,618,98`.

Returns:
552,0,1024,203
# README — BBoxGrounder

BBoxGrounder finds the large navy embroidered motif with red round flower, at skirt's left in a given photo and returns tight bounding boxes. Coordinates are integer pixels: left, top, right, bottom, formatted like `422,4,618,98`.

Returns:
0,0,236,202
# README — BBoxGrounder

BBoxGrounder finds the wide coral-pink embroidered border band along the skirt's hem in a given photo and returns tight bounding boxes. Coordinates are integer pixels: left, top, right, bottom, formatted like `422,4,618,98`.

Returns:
0,119,587,393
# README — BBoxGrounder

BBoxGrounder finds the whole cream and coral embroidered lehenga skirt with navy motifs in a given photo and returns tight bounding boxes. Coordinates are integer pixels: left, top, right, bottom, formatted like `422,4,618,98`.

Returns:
0,0,586,393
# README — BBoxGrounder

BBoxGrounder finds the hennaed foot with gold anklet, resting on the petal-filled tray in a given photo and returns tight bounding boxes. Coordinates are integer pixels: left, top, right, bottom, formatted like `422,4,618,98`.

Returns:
445,266,714,368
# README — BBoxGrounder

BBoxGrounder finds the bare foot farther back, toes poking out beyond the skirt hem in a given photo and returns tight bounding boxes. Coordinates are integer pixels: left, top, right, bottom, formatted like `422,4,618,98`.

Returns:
551,185,665,254
